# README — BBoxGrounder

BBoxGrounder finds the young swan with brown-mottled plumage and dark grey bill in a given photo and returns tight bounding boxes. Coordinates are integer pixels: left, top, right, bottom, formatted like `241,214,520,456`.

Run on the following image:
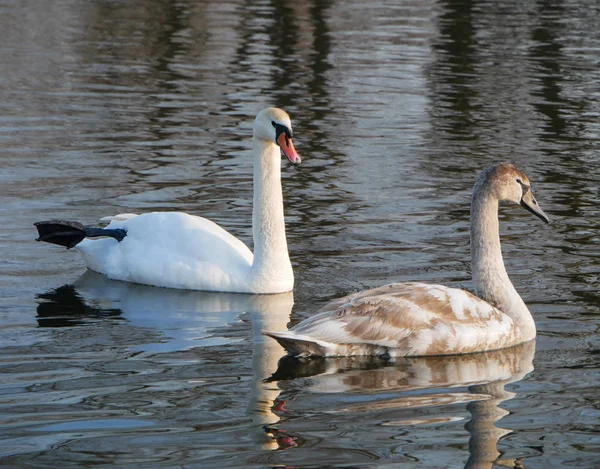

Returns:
265,164,549,356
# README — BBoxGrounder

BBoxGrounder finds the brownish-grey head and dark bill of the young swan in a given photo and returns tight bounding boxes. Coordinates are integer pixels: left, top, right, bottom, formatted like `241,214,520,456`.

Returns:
473,163,550,223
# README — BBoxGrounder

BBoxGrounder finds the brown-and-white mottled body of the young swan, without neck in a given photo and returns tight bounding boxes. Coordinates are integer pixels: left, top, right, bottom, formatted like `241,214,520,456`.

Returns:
270,283,516,356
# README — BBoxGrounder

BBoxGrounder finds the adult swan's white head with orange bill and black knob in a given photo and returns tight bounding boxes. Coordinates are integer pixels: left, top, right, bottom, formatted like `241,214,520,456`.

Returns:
254,107,302,164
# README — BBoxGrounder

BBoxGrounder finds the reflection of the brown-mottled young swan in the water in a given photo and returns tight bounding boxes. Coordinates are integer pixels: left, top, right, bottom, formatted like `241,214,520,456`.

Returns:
267,341,535,469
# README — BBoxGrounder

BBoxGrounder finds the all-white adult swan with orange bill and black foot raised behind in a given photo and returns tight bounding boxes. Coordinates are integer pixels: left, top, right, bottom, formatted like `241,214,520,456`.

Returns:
35,108,300,293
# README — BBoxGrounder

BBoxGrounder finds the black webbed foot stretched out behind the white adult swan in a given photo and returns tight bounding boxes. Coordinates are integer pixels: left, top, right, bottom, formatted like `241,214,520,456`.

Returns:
34,220,127,249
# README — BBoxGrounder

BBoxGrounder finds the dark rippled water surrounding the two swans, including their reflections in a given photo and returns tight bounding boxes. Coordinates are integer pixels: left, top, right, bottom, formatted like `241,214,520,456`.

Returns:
0,0,600,469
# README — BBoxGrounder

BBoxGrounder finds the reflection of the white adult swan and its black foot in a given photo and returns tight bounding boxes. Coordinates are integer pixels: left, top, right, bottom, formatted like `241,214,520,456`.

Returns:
37,271,294,450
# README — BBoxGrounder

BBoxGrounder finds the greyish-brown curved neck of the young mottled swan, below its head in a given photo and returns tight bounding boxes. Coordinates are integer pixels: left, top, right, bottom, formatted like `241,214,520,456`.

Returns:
471,185,535,340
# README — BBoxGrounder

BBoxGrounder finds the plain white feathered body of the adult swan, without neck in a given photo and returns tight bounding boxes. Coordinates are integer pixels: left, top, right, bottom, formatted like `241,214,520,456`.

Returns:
77,212,253,291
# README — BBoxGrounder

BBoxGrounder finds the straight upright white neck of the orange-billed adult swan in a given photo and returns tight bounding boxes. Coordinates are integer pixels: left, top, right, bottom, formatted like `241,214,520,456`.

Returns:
252,137,294,283
